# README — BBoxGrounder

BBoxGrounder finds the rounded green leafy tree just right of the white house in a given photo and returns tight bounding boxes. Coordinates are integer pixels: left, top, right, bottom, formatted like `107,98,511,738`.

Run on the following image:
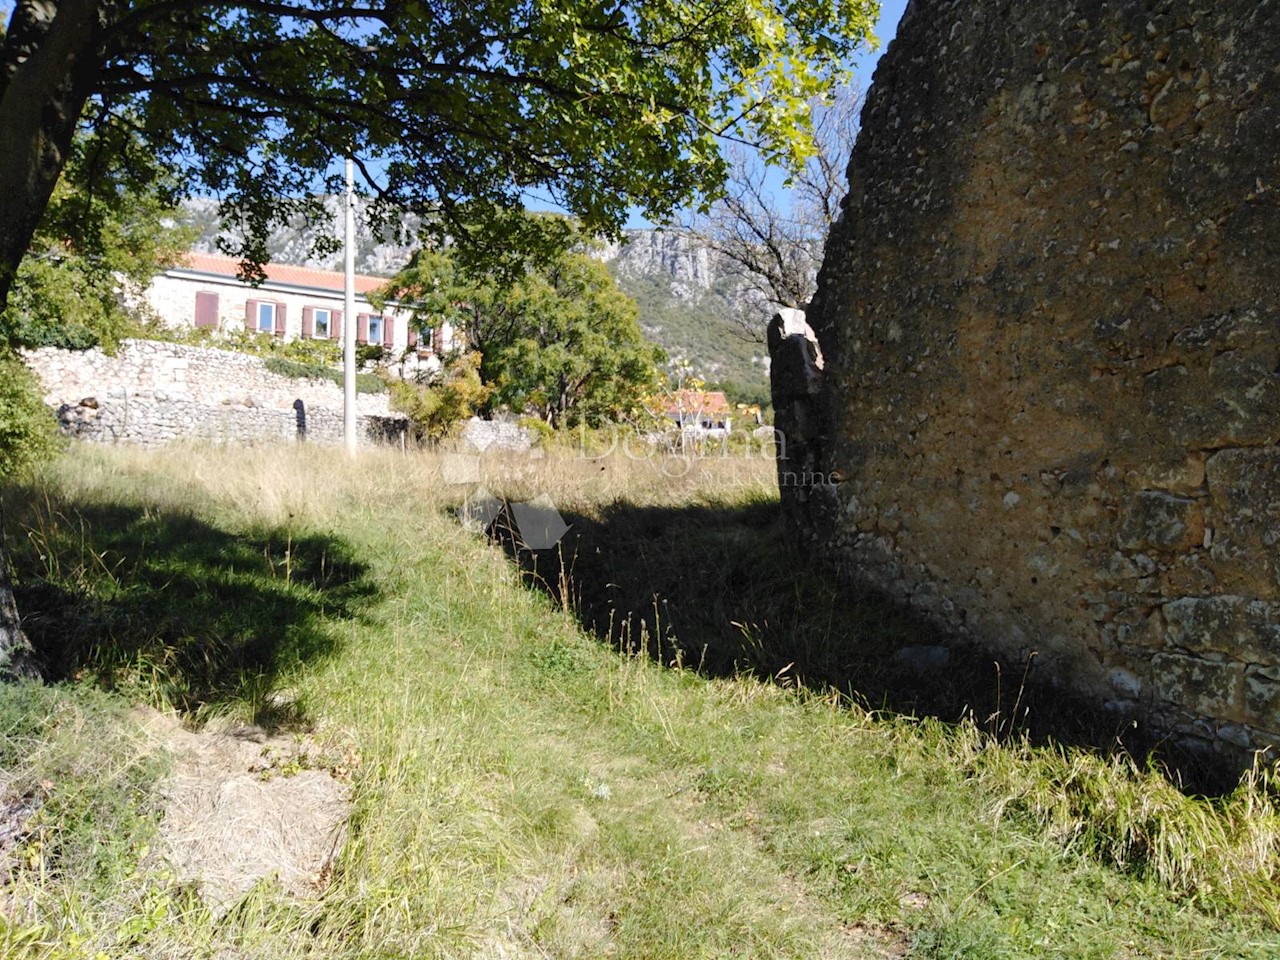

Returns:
378,227,662,428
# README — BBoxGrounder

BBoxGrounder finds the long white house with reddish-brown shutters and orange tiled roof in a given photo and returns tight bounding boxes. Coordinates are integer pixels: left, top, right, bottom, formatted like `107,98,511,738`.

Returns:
146,253,461,358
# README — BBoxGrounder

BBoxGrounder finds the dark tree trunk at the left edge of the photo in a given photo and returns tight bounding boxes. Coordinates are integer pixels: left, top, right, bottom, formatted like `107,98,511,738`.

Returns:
0,0,114,680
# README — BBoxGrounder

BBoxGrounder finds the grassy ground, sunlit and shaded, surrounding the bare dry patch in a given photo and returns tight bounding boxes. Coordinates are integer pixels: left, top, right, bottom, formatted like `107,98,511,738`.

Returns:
0,448,1280,959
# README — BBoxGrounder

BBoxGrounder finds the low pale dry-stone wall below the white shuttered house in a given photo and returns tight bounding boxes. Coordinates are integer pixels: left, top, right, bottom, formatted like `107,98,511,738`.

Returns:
26,340,407,445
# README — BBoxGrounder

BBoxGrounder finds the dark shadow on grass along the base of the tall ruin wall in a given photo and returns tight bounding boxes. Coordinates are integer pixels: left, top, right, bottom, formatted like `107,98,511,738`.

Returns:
494,500,1239,794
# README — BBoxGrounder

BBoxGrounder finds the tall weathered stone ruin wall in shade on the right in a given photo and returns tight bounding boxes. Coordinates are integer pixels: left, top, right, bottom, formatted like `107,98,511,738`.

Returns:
774,0,1280,756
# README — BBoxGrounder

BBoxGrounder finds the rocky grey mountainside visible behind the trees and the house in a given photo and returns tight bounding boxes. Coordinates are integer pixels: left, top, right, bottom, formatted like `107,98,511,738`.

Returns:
186,197,768,403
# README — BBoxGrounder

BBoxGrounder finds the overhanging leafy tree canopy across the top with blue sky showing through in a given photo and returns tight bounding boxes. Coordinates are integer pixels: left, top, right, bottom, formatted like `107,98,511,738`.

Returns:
0,0,877,306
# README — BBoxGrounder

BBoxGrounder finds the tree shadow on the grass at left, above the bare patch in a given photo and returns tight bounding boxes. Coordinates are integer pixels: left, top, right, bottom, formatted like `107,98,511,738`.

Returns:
6,497,375,726
